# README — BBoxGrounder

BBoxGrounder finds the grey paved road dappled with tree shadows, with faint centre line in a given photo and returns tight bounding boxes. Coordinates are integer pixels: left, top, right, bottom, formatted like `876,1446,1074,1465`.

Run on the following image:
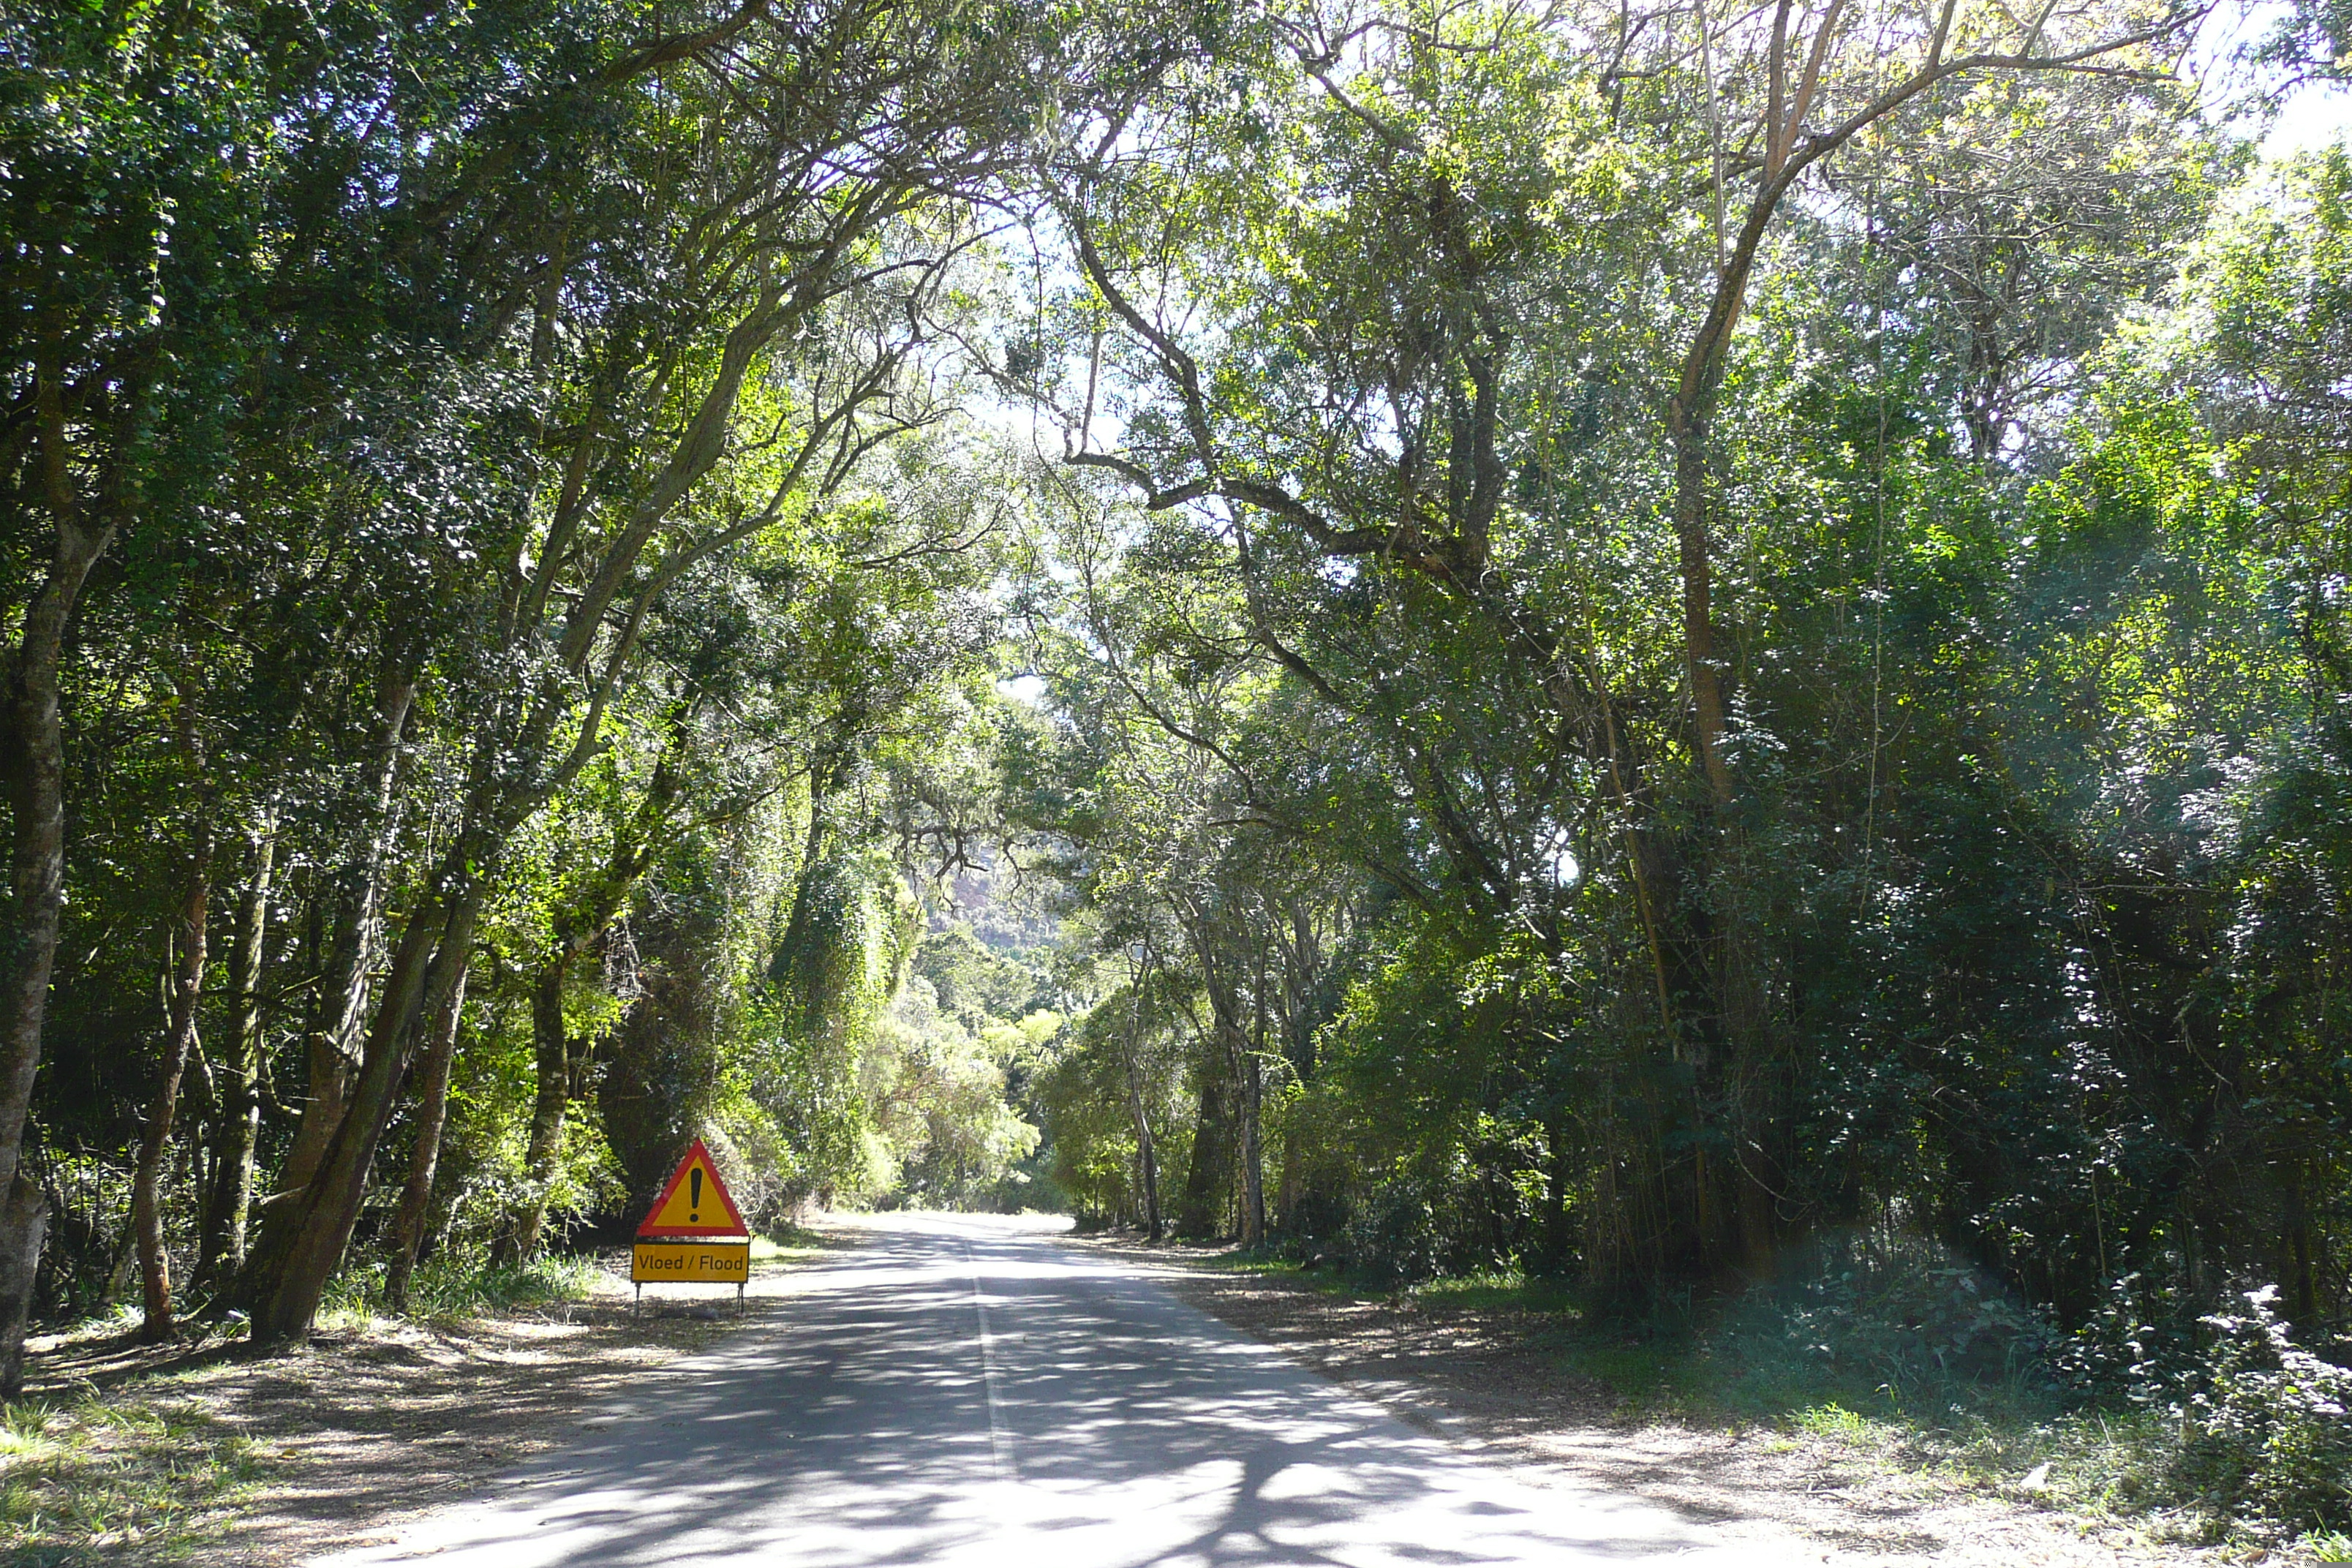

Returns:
317,1215,1778,1568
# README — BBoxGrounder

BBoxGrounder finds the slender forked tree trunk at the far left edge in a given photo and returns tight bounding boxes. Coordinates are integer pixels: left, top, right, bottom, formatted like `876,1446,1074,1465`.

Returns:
0,451,116,1399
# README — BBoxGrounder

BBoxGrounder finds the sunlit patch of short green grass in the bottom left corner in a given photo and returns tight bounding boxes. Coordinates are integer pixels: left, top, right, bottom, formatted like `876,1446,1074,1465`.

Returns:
0,1378,268,1568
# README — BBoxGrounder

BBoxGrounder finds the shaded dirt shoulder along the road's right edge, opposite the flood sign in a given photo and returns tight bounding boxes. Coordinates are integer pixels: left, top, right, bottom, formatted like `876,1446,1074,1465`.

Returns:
1072,1237,2286,1568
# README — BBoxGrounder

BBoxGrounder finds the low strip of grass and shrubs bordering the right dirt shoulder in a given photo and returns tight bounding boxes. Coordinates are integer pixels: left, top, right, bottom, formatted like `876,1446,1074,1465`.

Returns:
1260,1235,2352,1561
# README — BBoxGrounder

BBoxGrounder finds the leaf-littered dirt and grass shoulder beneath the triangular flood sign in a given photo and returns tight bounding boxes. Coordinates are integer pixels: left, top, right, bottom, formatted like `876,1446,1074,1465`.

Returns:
0,1232,856,1568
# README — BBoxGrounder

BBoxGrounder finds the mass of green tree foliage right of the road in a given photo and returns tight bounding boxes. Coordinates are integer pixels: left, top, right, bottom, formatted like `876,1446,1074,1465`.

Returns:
1002,7,2352,1528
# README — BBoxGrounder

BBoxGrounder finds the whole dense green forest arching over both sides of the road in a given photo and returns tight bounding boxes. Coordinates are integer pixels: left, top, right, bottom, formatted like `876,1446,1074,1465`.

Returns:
0,0,2352,1528
